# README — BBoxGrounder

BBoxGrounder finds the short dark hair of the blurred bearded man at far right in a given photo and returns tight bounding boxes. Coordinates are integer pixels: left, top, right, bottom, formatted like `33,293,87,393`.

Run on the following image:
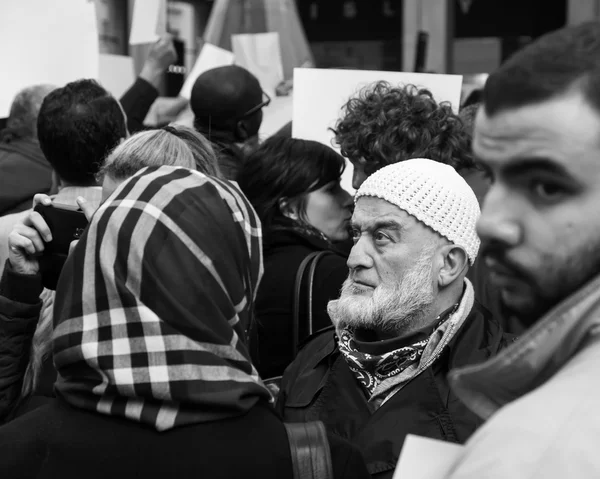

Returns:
483,22,600,116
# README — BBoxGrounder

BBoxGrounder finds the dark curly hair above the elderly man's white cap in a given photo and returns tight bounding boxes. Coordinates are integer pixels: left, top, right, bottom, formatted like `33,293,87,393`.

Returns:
334,81,473,174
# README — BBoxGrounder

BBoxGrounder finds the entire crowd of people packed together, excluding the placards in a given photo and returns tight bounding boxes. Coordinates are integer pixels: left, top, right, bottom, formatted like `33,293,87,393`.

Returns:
0,22,600,479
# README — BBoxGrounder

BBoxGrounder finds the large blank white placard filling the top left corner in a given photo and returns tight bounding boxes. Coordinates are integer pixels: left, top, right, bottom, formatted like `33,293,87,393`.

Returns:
0,0,98,118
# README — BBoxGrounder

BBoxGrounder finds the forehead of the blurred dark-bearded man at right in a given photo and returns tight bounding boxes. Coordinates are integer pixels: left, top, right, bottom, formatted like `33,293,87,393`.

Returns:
473,93,600,180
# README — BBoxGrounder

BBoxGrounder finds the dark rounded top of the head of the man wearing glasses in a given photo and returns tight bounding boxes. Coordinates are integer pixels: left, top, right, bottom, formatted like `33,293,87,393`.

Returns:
190,65,263,128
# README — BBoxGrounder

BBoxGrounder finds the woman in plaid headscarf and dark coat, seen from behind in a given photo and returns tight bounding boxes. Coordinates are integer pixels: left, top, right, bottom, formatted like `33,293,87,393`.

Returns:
0,167,368,479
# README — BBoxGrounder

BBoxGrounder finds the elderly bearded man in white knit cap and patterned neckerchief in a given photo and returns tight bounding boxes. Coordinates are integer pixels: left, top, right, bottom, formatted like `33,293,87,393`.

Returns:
277,159,508,478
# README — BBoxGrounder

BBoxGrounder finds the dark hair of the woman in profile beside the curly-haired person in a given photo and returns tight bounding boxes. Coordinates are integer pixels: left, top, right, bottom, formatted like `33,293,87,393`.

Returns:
238,136,346,230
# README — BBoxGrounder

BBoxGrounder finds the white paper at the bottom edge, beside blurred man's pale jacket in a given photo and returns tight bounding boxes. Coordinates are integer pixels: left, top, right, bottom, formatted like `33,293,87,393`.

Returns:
392,434,464,479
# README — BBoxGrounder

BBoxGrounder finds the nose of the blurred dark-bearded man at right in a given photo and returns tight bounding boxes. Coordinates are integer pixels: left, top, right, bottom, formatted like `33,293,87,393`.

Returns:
477,185,523,247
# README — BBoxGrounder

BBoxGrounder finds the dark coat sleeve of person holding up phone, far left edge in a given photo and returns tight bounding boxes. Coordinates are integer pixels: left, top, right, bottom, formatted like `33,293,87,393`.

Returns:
0,261,43,423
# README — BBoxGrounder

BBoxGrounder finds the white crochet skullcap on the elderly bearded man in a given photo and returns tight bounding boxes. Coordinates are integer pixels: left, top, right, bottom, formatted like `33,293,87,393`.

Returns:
354,158,480,265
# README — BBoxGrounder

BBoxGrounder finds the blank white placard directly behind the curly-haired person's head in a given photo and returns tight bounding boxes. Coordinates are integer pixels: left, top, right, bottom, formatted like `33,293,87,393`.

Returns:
292,68,462,192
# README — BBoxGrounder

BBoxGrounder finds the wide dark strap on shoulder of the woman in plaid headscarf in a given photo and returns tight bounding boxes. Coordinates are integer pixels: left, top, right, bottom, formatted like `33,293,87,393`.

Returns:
285,421,333,479
